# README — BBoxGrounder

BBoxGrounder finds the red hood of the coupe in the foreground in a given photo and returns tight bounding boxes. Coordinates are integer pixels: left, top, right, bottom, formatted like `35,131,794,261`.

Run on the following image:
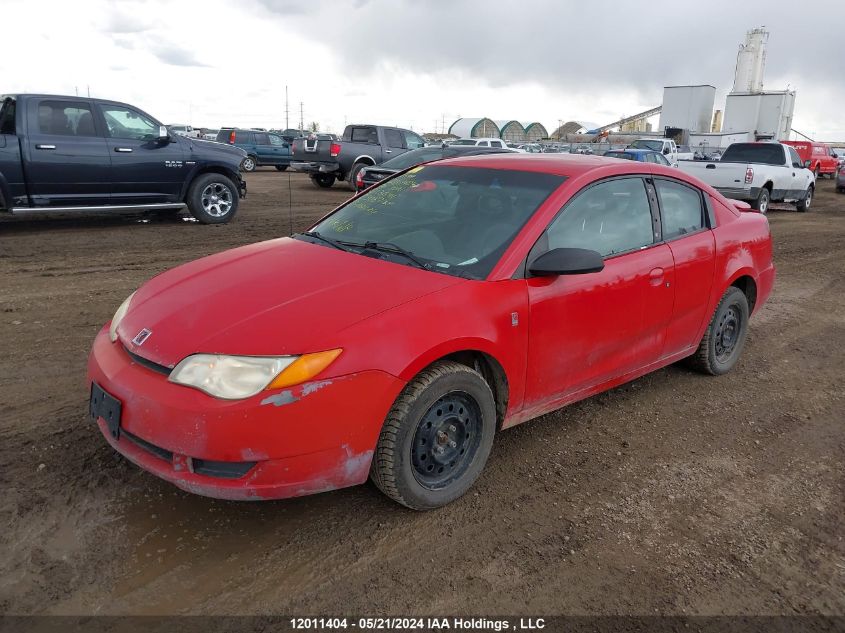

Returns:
118,238,463,367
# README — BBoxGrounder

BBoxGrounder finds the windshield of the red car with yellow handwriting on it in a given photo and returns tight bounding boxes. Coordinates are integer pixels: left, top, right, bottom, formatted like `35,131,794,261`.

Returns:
298,164,566,279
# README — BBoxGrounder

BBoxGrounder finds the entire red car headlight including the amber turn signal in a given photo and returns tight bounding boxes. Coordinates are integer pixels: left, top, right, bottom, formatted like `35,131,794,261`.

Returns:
168,349,342,400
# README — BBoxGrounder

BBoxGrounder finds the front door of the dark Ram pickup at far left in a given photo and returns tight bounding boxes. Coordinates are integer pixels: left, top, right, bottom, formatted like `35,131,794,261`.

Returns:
97,102,186,204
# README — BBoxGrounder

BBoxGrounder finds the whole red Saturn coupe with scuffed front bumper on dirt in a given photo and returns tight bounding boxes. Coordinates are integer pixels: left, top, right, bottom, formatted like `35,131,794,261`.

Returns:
88,154,775,509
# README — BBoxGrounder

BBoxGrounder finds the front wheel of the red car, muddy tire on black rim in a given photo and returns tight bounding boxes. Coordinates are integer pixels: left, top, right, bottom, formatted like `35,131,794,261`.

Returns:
370,361,496,510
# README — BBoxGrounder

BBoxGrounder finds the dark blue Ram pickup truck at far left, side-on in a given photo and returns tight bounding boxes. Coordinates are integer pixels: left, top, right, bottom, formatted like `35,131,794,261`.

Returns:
0,94,246,224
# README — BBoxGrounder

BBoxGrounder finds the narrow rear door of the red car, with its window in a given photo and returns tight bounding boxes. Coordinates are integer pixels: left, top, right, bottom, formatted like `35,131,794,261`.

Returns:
653,177,716,356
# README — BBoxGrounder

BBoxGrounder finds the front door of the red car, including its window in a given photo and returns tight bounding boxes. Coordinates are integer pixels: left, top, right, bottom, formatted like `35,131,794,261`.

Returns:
526,176,674,409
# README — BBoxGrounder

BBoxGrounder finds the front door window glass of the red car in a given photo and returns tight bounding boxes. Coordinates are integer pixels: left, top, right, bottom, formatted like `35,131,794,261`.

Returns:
546,178,654,257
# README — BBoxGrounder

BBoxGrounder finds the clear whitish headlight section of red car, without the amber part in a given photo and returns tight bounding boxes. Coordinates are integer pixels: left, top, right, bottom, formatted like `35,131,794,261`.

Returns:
168,354,296,400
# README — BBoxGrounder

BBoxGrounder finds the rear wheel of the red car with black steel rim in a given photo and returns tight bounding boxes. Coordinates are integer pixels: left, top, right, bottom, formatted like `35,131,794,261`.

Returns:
687,286,750,376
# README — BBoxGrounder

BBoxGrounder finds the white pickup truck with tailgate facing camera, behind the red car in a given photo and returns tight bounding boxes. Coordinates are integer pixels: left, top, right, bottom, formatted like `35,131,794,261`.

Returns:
678,142,816,213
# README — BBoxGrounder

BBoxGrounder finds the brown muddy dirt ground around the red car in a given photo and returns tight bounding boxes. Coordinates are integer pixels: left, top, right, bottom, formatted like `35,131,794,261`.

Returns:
0,170,845,616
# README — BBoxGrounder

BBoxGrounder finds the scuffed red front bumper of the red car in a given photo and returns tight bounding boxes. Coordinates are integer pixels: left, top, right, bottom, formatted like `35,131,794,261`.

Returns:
88,328,404,499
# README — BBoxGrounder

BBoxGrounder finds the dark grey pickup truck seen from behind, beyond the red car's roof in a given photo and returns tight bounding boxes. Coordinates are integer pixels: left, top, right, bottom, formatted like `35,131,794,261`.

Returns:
290,125,425,191
